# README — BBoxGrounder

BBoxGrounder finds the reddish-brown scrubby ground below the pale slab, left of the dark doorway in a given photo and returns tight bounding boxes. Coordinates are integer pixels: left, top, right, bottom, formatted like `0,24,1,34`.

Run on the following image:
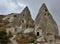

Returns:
16,34,36,44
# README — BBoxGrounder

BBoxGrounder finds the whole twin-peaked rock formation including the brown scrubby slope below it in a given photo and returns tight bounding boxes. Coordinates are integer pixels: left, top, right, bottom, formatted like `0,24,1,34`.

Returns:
0,4,60,44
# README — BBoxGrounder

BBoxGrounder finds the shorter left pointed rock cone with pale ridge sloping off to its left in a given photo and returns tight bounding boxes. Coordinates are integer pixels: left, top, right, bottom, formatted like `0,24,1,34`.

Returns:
3,7,34,27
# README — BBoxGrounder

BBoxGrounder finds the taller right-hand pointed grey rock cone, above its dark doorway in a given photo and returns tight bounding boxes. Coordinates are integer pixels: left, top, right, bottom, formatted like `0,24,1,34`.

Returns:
35,3,58,34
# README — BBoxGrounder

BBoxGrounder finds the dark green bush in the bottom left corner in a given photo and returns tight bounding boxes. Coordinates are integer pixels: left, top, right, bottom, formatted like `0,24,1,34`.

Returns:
0,31,9,44
